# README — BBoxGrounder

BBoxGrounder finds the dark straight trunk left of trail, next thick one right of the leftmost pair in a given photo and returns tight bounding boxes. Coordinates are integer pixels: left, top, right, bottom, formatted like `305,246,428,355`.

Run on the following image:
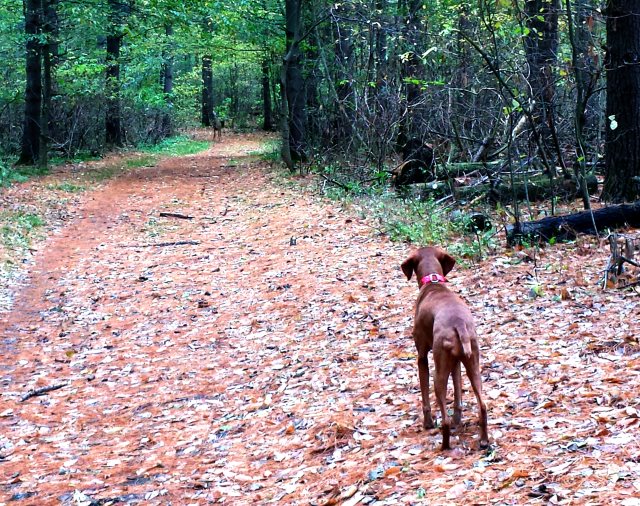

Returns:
105,0,125,146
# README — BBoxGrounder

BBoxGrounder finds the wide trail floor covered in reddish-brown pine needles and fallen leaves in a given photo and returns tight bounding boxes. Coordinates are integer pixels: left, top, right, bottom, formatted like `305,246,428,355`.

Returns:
0,131,640,506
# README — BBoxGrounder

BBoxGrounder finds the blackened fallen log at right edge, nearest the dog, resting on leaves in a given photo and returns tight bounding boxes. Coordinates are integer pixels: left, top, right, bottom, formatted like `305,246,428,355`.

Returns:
507,201,640,246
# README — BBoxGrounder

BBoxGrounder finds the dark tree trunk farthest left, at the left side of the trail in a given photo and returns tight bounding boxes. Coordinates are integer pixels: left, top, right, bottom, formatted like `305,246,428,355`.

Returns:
18,0,42,165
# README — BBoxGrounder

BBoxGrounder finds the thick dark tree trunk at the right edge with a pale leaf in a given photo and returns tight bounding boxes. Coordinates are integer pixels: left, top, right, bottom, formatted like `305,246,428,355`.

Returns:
602,0,640,202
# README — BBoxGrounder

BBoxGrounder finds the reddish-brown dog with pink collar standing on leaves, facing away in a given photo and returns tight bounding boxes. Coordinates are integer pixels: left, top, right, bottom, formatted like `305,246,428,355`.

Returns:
402,247,489,450
